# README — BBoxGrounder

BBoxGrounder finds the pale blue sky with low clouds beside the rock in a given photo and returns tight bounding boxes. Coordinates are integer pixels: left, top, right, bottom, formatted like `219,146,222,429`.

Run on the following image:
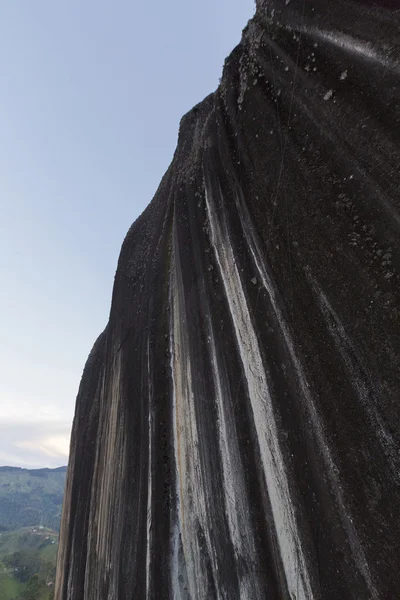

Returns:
0,0,253,467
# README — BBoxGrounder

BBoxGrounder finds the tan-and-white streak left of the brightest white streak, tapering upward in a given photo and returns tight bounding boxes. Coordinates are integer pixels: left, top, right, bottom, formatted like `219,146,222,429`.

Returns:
170,217,222,600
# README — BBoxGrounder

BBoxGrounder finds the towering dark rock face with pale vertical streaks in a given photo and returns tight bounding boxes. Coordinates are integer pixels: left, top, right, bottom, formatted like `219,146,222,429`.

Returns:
56,0,400,600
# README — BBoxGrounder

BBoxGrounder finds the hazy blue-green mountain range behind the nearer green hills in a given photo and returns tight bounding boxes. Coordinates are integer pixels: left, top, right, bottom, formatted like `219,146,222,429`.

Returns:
0,467,67,531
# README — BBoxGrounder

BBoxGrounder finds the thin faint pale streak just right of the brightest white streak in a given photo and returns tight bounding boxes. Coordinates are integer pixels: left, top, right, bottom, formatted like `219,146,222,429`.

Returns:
236,189,378,599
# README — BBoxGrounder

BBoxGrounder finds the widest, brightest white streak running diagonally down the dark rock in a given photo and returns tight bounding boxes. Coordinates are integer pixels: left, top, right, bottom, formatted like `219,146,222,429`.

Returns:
205,183,314,600
